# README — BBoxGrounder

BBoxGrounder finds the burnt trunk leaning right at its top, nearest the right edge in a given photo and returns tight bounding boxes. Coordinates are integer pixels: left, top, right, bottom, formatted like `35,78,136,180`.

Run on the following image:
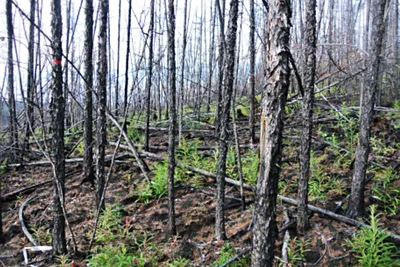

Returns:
348,0,387,218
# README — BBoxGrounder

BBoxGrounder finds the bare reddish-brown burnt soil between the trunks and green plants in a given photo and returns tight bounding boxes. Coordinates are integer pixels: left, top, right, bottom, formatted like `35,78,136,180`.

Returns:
0,114,400,266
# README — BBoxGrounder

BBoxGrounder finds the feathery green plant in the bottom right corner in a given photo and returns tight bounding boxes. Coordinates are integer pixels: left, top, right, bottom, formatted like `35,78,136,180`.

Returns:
348,205,400,267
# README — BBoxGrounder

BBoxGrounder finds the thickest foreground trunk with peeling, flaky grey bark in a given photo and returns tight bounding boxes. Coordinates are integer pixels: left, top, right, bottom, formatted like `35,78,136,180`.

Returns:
251,0,291,267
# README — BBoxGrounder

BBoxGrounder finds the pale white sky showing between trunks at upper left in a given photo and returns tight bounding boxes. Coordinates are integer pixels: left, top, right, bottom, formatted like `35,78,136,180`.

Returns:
0,0,209,100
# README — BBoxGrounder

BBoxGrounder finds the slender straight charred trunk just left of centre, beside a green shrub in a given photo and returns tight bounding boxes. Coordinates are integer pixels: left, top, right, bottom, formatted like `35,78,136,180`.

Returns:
168,0,176,235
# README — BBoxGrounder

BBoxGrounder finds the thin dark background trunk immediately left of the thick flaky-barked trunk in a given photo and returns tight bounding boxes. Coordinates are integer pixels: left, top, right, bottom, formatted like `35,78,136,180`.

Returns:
249,0,256,145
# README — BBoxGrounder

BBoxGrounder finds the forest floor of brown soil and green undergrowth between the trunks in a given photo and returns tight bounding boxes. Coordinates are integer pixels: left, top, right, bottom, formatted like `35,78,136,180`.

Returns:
0,102,400,266
